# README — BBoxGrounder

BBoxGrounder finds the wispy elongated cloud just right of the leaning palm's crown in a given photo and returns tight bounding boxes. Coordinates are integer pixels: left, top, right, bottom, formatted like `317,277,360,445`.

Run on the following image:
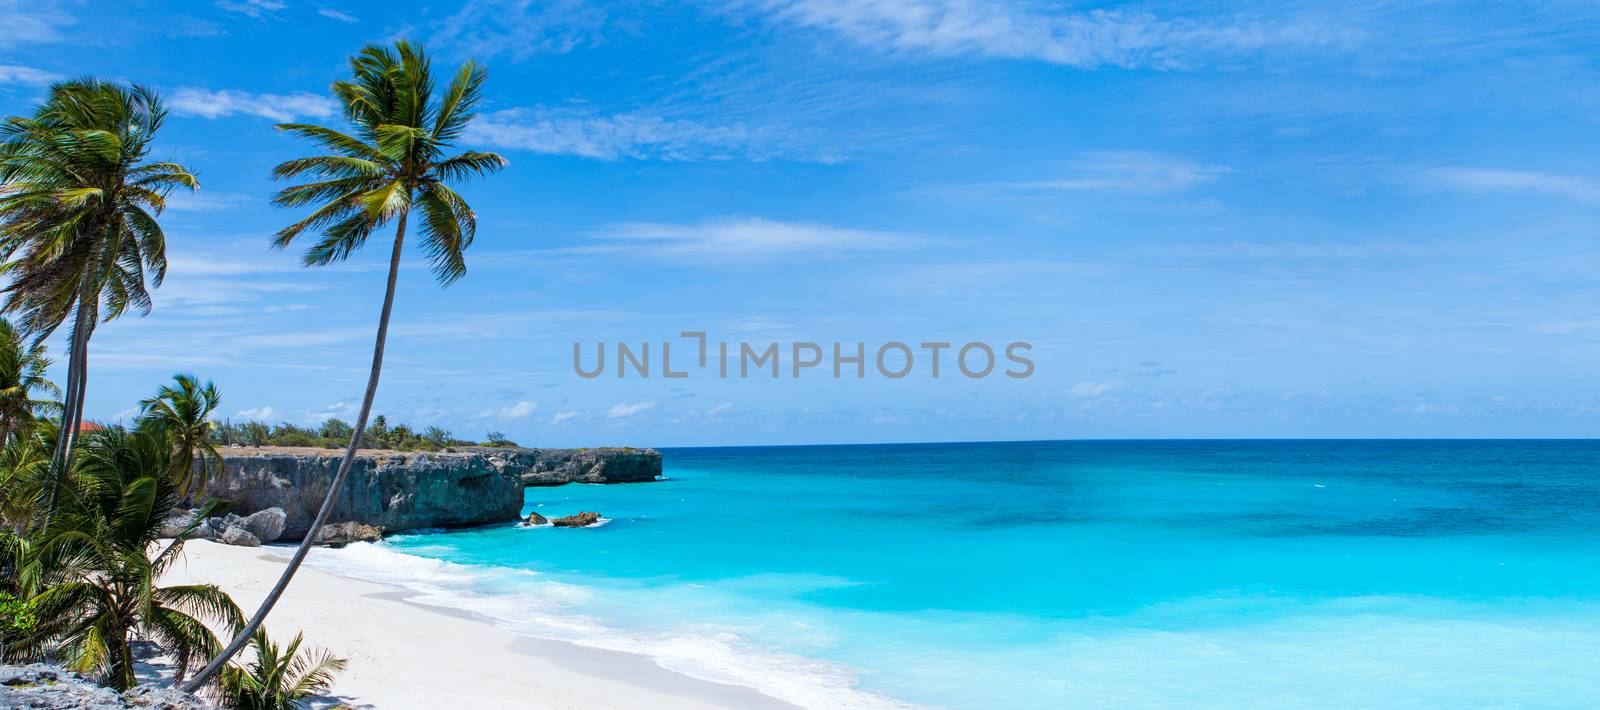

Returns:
467,109,835,162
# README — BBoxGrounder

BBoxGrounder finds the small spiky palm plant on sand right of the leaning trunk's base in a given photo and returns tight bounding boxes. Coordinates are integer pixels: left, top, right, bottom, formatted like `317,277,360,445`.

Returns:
222,630,346,710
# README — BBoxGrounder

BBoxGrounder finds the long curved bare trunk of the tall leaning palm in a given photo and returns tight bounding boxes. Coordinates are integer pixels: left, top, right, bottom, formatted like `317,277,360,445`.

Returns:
182,213,408,692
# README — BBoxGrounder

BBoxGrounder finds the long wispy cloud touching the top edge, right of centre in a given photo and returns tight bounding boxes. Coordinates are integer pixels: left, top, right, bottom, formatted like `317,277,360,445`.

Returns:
741,0,1349,69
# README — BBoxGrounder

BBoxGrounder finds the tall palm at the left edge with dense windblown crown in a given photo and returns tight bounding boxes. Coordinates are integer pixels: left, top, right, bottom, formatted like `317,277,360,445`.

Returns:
0,78,198,515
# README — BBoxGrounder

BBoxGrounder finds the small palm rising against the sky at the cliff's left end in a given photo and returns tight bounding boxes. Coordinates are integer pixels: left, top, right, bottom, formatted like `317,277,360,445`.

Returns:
139,374,222,496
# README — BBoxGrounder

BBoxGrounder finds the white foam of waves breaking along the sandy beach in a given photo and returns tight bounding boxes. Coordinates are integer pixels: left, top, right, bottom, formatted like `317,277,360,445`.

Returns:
307,540,912,710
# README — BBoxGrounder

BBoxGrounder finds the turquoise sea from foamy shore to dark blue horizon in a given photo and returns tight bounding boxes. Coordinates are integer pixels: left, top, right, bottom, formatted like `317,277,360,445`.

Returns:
302,441,1600,708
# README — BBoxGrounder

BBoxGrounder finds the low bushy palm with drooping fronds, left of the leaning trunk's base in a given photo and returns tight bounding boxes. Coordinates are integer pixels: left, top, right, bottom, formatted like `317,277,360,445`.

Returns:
16,427,243,689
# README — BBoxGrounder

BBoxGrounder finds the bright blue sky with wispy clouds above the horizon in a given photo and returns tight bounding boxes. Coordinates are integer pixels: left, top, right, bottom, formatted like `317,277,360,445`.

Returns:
0,0,1600,446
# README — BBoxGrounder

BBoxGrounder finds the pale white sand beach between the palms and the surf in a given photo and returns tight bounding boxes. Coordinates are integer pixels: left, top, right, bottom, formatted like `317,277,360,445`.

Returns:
162,540,795,710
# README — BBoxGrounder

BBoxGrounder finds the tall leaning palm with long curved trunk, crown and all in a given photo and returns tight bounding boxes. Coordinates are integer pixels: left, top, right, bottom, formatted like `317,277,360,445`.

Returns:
184,42,506,691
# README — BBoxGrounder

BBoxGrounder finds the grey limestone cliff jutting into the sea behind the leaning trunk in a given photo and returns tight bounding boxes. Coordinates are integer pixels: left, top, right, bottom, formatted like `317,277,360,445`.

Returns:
203,446,661,540
